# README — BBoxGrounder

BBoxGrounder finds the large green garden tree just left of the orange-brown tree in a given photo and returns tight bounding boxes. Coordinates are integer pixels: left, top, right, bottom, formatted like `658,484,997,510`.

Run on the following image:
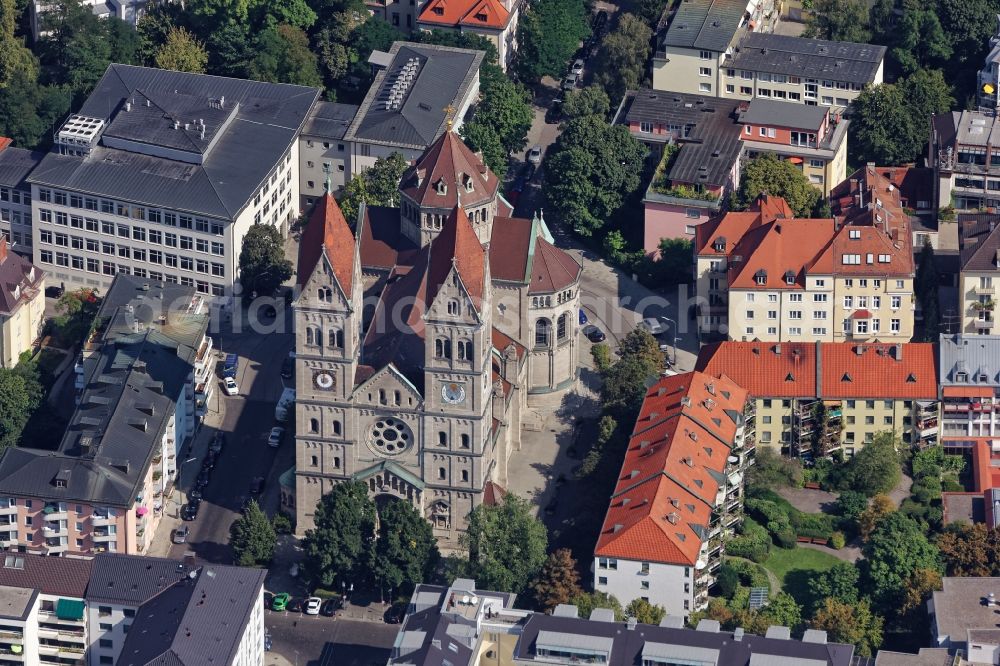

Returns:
861,511,941,612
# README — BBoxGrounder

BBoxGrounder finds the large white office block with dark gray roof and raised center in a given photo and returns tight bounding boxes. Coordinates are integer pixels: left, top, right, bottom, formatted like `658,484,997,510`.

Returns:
27,64,319,296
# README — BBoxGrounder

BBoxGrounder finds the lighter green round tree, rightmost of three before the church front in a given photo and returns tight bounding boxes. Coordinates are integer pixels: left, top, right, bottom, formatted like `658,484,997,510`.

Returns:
462,493,549,594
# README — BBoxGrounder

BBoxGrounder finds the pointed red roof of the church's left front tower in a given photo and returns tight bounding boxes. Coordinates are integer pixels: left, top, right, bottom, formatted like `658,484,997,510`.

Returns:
297,192,355,288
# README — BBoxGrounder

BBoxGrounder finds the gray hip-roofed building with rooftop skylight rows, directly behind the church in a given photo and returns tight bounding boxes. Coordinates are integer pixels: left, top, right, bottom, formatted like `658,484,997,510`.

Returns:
344,42,485,180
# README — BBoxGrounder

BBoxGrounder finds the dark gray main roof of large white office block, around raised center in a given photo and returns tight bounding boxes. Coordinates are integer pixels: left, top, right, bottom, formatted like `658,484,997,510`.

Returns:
28,64,319,219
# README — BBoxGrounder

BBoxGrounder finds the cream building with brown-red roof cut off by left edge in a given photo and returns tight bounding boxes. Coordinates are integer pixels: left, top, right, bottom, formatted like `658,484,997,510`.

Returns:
0,238,45,368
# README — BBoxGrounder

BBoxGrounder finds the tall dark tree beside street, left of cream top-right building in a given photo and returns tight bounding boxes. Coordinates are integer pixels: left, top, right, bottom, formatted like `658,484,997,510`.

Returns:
594,14,653,100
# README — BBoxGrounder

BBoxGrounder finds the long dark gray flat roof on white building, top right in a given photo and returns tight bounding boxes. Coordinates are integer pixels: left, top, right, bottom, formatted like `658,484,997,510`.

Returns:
725,32,886,85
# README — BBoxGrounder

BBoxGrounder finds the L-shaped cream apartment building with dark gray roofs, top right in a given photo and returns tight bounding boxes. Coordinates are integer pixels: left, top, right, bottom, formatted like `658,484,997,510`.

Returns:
653,0,886,110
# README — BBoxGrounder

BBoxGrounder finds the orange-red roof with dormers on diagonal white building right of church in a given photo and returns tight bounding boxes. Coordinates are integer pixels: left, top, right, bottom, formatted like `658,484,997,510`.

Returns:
595,372,747,566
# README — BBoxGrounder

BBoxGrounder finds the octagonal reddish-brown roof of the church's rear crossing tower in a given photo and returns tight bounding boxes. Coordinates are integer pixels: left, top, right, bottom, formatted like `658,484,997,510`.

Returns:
400,131,500,210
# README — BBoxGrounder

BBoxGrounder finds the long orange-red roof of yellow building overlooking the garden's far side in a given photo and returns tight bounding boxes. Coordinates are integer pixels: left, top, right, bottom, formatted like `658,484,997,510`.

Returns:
695,342,937,400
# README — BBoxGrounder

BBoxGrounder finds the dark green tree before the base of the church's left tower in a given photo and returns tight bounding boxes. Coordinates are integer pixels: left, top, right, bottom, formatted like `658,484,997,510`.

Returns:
302,481,376,588
